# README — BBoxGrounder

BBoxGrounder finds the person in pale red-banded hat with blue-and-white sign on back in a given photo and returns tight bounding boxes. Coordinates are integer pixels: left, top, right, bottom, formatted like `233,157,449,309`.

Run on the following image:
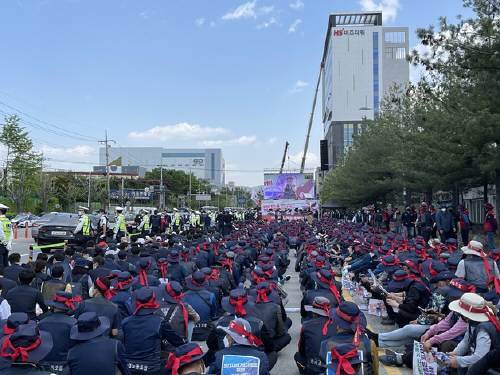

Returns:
208,318,269,375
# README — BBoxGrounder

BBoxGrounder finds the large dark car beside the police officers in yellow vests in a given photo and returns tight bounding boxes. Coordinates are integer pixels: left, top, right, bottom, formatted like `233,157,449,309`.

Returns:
32,212,99,251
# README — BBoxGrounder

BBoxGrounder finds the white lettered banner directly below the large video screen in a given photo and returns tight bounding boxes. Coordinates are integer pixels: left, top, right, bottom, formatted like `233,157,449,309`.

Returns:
261,199,319,220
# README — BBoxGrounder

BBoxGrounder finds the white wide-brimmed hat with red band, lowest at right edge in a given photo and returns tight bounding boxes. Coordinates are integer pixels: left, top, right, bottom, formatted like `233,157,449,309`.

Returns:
449,293,500,331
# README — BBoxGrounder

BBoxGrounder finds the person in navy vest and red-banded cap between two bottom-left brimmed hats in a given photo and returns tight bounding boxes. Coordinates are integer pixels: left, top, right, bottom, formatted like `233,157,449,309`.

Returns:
38,291,82,374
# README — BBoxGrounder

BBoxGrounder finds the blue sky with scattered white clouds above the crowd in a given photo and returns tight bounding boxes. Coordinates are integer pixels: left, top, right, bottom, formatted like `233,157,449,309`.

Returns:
0,0,470,185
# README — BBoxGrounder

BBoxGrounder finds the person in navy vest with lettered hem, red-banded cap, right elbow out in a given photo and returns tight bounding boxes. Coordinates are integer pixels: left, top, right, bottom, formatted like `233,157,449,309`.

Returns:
122,287,184,375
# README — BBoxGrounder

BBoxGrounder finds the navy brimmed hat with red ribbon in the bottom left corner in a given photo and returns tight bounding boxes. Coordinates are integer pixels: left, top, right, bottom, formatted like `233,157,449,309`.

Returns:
0,322,53,363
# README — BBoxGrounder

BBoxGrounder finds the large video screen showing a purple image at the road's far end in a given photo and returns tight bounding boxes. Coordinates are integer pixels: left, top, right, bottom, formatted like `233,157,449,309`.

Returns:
264,173,316,200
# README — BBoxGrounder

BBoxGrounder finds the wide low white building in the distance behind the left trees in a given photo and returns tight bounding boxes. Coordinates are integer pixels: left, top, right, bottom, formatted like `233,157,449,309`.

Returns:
99,147,225,187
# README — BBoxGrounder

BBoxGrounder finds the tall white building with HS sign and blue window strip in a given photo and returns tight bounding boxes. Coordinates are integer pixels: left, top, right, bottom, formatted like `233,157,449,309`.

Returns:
322,12,410,168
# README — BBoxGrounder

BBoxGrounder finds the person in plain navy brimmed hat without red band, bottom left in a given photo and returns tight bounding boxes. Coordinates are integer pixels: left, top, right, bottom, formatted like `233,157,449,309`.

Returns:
67,312,130,375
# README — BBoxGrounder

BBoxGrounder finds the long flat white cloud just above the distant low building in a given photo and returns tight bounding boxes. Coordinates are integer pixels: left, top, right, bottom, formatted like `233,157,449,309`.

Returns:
128,122,228,141
